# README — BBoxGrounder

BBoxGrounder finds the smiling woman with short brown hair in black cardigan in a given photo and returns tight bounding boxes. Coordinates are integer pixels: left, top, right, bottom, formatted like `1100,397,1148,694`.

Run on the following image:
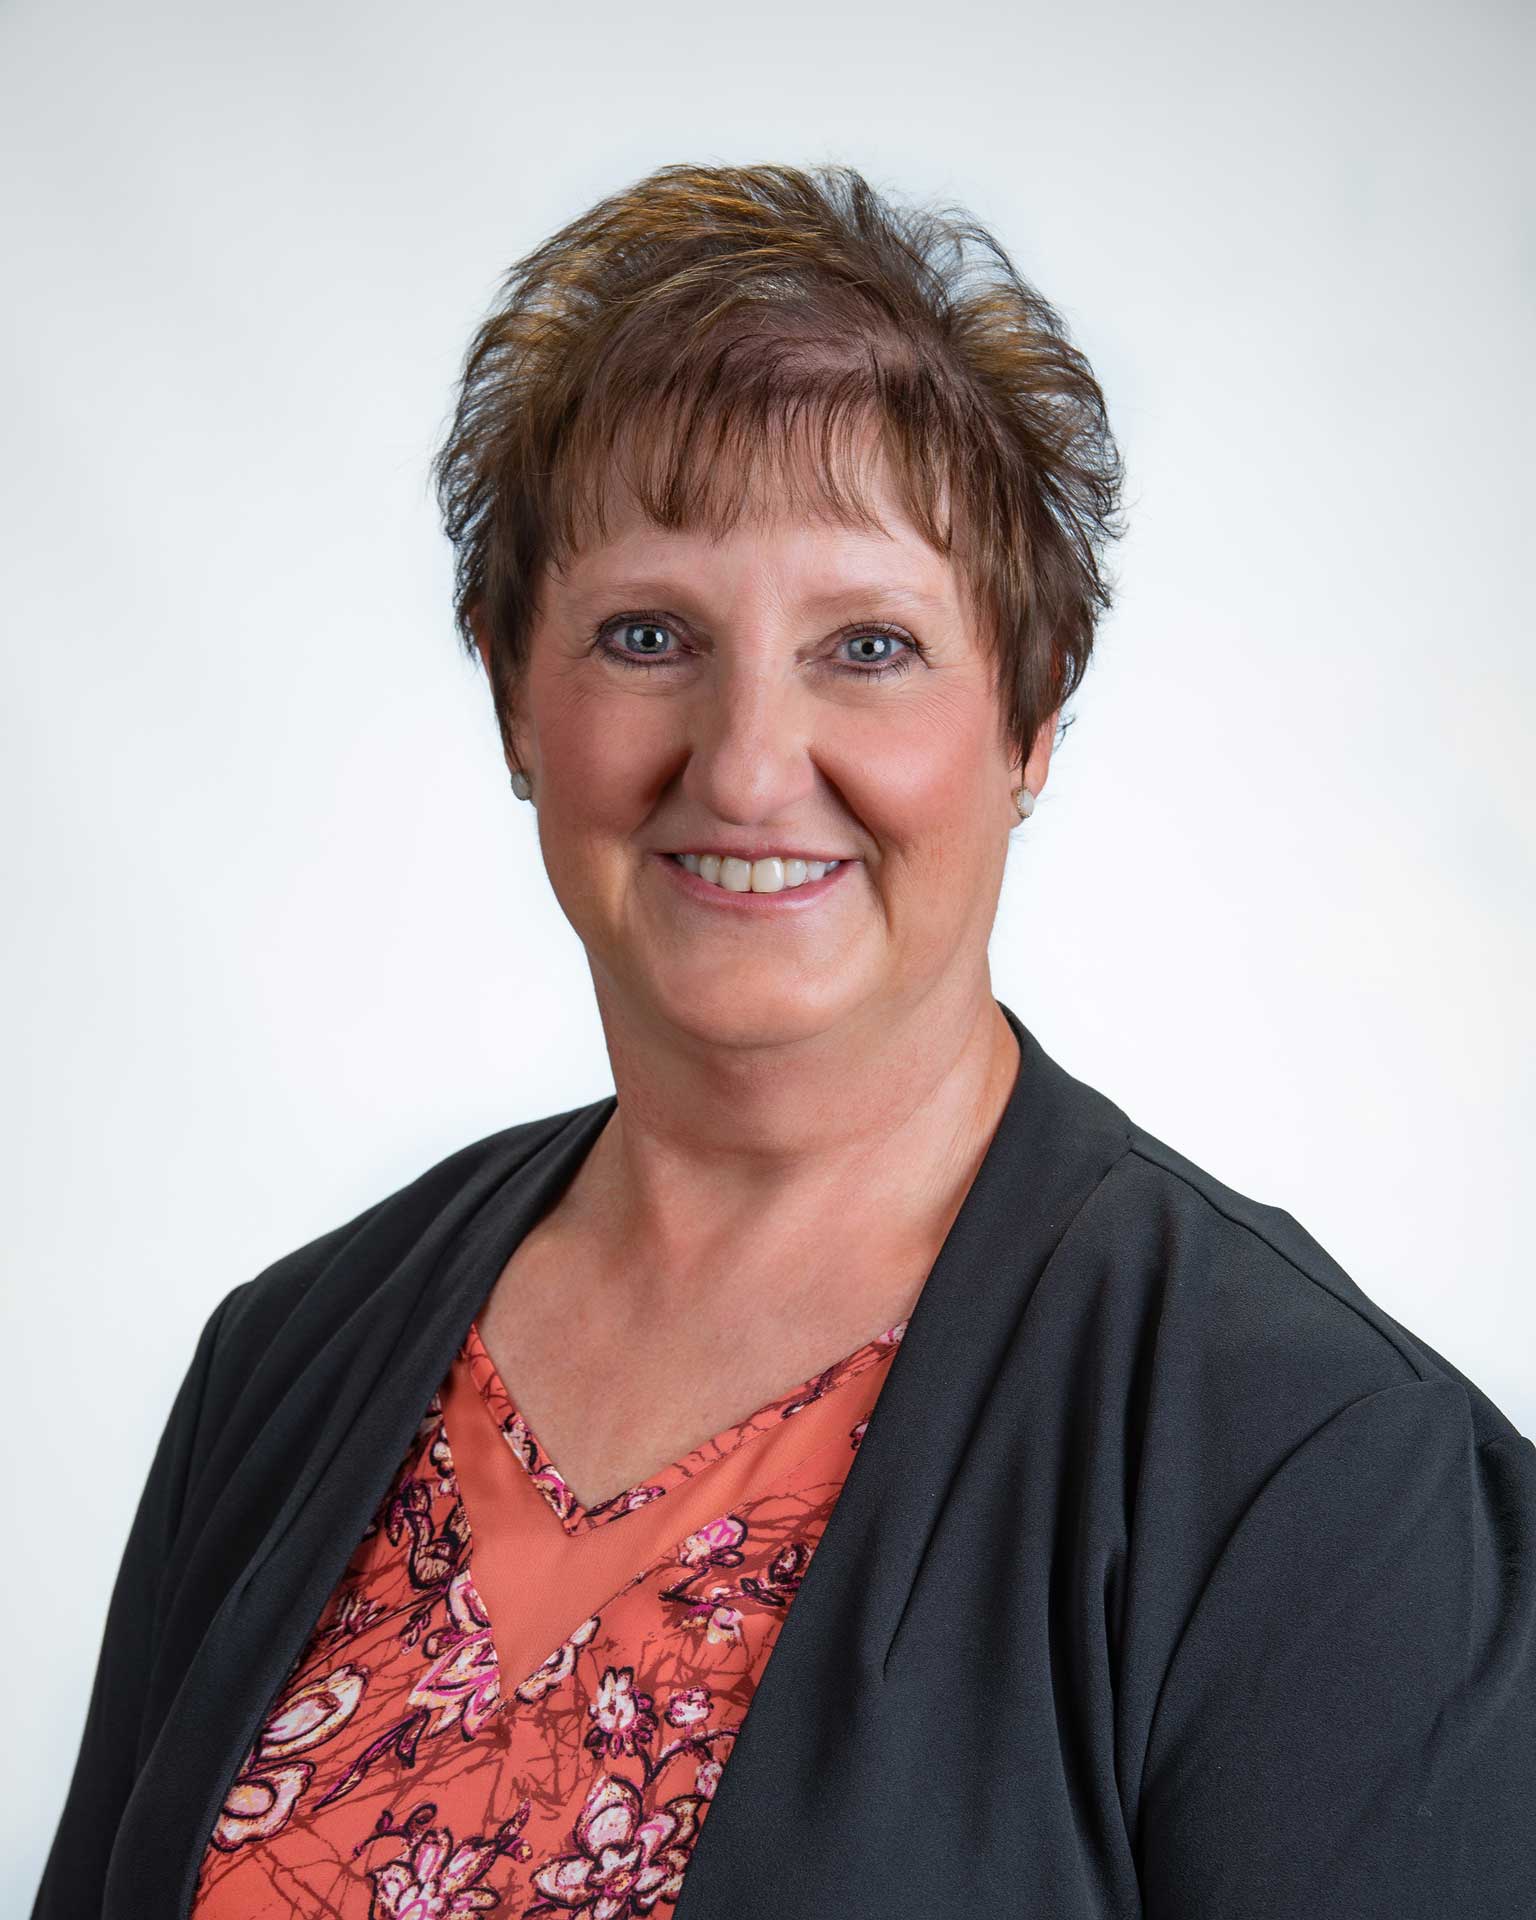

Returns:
36,167,1536,1920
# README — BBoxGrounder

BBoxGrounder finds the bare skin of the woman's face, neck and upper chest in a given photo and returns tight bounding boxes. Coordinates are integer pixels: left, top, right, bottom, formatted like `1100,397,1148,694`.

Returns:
480,456,1056,1503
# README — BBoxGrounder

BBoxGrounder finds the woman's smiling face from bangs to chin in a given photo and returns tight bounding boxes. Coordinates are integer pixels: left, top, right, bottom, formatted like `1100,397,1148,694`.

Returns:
491,456,1054,1046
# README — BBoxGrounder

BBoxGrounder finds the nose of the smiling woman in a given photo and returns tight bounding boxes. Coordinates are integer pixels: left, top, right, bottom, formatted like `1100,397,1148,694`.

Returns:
682,655,818,826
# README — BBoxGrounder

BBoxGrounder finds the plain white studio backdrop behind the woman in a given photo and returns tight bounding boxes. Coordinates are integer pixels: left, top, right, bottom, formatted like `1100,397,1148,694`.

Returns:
0,0,1536,1912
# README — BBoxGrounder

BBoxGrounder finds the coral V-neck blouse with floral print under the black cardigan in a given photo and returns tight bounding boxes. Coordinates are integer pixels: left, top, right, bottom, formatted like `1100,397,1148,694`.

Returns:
192,1321,906,1920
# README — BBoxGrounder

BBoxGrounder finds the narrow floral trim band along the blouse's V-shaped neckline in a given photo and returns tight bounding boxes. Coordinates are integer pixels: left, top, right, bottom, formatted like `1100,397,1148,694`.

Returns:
459,1319,906,1534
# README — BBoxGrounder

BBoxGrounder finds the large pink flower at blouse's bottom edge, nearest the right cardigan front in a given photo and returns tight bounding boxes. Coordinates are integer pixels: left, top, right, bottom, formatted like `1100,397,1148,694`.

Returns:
528,1774,701,1920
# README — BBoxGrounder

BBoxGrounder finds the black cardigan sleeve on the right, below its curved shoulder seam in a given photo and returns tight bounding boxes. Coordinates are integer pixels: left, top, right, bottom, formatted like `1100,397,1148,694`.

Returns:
1139,1379,1536,1920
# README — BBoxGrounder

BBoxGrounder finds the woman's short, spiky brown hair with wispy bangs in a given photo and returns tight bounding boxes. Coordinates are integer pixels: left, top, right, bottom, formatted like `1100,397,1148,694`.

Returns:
432,165,1123,755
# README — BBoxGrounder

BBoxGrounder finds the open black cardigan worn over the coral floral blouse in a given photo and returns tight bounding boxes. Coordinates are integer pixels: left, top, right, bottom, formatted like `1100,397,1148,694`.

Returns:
35,1008,1536,1920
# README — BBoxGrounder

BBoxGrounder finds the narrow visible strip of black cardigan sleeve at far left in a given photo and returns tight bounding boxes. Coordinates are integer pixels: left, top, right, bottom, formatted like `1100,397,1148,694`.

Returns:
33,1283,250,1920
